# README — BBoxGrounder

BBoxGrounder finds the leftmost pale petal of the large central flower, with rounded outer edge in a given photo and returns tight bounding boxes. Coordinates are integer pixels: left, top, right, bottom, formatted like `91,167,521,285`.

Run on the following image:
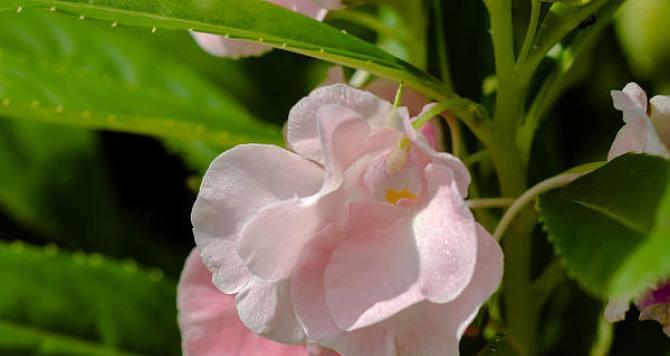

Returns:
191,145,323,293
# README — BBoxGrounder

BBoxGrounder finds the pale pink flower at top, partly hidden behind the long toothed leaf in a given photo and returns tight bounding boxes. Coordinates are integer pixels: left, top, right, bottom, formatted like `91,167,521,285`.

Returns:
193,0,330,59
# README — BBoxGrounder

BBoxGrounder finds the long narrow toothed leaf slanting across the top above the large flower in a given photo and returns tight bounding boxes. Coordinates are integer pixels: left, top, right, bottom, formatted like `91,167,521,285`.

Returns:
3,0,454,100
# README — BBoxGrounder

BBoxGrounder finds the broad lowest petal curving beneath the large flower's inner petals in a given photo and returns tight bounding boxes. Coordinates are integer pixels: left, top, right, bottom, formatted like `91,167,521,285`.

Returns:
292,220,503,356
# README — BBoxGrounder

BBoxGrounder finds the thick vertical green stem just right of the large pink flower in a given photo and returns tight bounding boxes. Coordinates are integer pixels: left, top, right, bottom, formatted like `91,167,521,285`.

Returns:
484,0,538,355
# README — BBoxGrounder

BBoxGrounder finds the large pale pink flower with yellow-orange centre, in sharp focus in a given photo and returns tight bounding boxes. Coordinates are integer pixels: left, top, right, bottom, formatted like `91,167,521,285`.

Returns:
192,84,502,355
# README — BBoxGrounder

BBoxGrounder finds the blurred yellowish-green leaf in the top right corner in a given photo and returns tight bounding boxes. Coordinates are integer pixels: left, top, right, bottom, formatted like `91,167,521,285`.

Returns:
616,0,670,80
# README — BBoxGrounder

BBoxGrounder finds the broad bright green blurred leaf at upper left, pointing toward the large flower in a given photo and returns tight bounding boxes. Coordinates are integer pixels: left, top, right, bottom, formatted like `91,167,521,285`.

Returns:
0,10,281,146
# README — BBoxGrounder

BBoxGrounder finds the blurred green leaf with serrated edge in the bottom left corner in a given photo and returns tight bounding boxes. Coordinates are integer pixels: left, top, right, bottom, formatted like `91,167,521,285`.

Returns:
0,242,180,355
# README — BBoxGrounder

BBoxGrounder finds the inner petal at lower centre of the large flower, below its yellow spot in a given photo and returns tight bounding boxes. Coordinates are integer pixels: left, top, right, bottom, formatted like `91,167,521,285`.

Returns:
323,204,424,331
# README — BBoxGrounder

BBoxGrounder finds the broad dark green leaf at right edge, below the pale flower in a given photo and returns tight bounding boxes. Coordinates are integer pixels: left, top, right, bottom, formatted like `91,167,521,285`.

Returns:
538,155,670,297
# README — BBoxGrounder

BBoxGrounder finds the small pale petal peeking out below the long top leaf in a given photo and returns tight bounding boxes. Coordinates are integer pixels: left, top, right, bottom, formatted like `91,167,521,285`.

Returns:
192,32,272,59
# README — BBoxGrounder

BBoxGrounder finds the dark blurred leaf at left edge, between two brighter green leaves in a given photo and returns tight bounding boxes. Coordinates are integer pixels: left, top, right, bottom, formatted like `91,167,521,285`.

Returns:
0,120,186,272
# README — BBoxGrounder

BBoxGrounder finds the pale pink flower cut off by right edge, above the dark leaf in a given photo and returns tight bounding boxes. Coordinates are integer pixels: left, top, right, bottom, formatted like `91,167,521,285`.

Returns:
608,83,670,160
